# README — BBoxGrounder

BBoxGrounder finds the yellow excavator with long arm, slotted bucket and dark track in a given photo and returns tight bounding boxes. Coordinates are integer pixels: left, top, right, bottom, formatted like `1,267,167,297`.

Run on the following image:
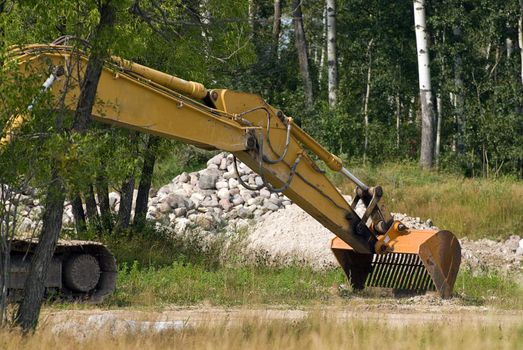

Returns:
0,40,461,301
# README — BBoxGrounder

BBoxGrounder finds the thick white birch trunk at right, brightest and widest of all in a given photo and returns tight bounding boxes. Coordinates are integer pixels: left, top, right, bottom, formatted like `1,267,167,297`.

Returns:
414,0,434,169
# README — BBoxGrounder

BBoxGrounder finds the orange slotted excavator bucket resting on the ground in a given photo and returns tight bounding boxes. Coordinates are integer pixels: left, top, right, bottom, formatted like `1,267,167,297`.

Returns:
331,230,461,298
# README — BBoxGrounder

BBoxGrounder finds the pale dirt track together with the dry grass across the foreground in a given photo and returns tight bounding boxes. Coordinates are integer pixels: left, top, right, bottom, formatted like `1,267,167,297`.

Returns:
17,295,523,350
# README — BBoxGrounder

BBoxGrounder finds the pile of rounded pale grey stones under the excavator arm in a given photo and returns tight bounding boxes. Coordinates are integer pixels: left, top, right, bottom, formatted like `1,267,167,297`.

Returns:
147,153,292,233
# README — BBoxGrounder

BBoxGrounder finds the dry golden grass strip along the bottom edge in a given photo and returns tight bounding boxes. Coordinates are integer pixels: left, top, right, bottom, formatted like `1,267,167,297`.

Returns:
0,313,523,350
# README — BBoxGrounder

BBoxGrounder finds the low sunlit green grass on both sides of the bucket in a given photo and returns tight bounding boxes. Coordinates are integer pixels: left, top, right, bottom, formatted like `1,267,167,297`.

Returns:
99,263,523,310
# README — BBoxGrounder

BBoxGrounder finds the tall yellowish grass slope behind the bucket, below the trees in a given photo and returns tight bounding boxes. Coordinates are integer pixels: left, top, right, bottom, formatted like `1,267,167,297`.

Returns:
334,163,523,239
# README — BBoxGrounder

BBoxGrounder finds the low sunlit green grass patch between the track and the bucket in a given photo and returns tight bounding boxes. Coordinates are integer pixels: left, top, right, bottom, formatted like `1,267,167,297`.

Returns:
108,263,345,306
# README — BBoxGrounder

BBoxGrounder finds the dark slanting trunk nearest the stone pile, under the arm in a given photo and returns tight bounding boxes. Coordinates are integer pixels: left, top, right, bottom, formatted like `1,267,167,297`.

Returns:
134,135,159,226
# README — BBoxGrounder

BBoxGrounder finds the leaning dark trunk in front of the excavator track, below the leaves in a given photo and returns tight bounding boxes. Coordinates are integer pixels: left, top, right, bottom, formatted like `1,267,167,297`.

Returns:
16,170,65,333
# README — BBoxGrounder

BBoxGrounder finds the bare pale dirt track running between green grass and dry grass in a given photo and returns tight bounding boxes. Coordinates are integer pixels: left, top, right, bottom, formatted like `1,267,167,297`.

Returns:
41,296,523,338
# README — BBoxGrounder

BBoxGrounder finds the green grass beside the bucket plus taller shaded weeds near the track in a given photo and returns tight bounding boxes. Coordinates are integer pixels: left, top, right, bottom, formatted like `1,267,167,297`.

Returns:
87,216,523,310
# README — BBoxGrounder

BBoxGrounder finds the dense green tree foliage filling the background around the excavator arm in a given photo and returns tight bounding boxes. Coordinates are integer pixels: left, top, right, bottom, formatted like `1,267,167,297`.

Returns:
0,0,523,216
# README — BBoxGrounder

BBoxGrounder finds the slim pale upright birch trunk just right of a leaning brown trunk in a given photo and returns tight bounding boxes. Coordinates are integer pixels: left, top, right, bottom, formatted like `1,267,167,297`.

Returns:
327,0,338,108
